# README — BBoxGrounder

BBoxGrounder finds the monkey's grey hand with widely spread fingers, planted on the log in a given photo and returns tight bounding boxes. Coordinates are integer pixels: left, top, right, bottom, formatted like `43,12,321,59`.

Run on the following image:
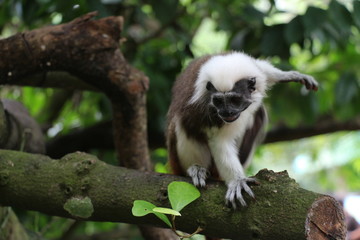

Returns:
225,178,256,209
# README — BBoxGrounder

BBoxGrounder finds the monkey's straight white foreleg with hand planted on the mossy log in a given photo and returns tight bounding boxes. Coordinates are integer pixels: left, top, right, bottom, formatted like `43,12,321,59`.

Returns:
209,141,256,209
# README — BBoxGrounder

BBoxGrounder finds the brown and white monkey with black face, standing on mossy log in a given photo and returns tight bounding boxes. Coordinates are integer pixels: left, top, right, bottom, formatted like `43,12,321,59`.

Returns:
166,51,318,209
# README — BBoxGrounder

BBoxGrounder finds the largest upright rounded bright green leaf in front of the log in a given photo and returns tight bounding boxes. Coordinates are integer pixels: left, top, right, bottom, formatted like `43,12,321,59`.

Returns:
168,181,200,212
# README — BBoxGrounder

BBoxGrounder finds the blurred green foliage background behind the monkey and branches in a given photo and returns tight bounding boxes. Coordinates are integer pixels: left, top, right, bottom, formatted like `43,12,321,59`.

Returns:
0,0,360,239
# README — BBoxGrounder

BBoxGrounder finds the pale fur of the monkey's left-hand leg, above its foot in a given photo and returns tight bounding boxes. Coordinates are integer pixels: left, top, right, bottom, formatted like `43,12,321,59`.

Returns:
175,118,211,169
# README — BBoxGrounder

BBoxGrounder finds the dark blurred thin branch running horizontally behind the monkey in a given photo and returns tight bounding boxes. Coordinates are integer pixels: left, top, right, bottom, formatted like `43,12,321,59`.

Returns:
46,115,360,158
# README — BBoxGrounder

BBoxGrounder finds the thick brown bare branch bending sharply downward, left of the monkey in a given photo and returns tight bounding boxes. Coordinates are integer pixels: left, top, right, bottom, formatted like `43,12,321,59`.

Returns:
0,13,150,169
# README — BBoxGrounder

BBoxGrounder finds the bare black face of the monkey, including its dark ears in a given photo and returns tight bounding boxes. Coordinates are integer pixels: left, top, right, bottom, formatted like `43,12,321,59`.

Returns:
206,78,256,123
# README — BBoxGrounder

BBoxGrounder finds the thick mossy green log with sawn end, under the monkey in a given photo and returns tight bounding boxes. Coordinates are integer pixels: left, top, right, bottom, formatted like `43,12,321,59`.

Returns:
0,150,345,240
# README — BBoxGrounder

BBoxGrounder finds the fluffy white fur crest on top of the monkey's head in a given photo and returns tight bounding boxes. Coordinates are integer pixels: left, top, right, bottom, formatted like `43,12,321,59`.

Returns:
189,52,268,104
